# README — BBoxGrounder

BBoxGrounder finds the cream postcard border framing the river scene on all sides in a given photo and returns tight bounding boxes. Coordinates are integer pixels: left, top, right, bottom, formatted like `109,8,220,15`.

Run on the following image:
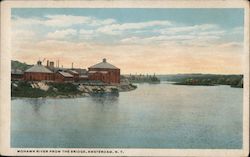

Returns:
0,0,249,156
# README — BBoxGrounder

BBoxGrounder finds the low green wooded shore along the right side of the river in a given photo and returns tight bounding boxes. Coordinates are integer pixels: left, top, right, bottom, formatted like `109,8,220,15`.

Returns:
158,74,243,88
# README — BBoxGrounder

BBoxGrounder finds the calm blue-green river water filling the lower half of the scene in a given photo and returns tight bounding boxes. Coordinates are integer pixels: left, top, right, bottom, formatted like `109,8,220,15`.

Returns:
11,82,243,149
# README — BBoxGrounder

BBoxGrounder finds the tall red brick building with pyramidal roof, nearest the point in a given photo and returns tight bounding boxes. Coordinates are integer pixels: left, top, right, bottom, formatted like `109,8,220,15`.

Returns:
88,58,120,84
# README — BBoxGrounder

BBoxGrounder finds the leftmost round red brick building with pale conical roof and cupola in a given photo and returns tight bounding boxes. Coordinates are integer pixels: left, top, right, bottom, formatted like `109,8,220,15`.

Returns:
24,61,54,81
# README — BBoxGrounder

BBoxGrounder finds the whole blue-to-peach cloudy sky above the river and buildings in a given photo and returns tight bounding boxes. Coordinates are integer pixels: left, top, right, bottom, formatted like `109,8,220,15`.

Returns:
11,8,244,74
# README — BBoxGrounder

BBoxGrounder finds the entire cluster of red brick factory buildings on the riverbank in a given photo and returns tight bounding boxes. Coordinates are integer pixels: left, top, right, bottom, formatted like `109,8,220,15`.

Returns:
20,59,120,84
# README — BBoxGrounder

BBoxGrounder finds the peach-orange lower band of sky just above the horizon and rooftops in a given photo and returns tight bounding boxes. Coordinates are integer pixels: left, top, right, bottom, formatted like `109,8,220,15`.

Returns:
13,40,242,74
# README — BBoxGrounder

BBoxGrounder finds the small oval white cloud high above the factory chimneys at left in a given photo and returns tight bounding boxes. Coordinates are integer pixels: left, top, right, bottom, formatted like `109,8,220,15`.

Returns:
47,29,77,39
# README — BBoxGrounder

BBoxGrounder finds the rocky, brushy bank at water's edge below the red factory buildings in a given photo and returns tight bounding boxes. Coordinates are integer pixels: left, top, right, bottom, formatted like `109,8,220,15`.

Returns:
11,81,137,98
